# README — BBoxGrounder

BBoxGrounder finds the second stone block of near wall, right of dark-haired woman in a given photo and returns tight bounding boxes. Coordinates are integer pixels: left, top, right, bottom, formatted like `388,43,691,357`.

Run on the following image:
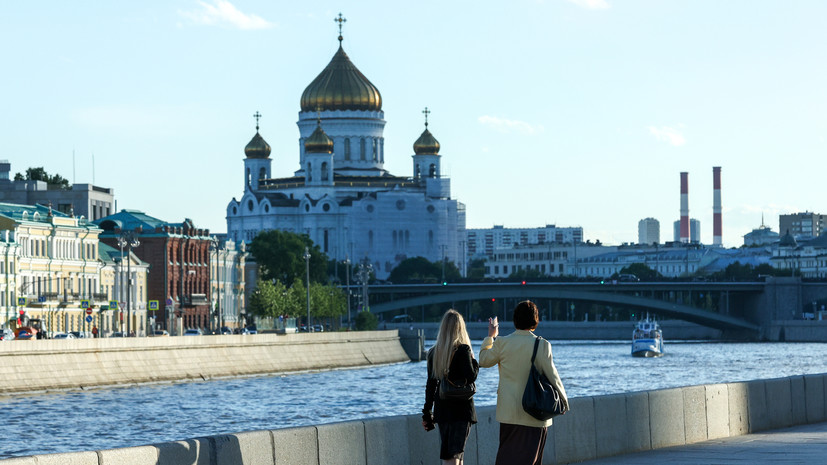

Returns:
594,394,629,457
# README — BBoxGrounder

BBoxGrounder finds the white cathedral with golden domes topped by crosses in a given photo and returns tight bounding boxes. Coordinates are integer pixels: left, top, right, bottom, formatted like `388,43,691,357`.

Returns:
227,22,465,279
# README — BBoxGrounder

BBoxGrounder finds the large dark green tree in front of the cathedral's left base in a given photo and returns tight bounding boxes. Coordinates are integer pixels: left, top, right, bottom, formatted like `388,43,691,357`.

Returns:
250,229,328,287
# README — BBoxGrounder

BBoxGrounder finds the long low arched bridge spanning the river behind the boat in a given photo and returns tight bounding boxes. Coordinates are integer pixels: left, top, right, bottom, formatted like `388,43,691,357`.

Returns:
369,278,812,333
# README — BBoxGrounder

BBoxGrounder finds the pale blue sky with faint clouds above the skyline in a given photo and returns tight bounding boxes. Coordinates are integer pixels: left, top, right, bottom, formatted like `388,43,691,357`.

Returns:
0,0,827,246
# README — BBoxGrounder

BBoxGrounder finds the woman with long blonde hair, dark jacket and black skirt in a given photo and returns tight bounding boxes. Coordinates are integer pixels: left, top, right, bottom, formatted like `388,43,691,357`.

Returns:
422,310,480,465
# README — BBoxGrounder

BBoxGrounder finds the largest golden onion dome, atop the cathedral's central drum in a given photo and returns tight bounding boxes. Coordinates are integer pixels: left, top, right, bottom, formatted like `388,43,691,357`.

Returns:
301,43,382,111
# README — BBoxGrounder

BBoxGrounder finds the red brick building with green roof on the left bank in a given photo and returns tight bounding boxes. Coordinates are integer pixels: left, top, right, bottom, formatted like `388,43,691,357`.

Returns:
95,210,214,332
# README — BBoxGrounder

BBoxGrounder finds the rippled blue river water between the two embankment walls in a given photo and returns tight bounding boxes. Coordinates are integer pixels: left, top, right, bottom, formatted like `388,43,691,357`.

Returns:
0,341,827,458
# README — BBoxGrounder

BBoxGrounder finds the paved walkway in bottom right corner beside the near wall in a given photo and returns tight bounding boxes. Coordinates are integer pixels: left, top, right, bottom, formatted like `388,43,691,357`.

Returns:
581,423,827,465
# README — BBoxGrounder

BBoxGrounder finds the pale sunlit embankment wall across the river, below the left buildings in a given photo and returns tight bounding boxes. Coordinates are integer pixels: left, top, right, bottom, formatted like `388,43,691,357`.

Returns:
0,330,409,394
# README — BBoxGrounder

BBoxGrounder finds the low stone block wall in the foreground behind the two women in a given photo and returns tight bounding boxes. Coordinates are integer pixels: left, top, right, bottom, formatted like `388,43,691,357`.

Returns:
6,374,827,465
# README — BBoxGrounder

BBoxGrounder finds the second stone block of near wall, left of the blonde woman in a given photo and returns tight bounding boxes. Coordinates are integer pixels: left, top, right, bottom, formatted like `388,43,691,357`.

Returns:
363,416,410,465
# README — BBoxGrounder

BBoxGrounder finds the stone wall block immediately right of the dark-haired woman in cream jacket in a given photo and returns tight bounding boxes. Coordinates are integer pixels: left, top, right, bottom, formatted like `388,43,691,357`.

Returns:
546,397,597,463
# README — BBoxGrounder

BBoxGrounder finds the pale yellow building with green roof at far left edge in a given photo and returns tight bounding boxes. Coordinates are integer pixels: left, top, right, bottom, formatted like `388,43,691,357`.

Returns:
0,203,102,334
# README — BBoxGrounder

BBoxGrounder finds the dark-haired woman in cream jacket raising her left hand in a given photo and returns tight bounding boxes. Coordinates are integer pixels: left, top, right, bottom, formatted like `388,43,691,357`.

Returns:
480,300,569,465
